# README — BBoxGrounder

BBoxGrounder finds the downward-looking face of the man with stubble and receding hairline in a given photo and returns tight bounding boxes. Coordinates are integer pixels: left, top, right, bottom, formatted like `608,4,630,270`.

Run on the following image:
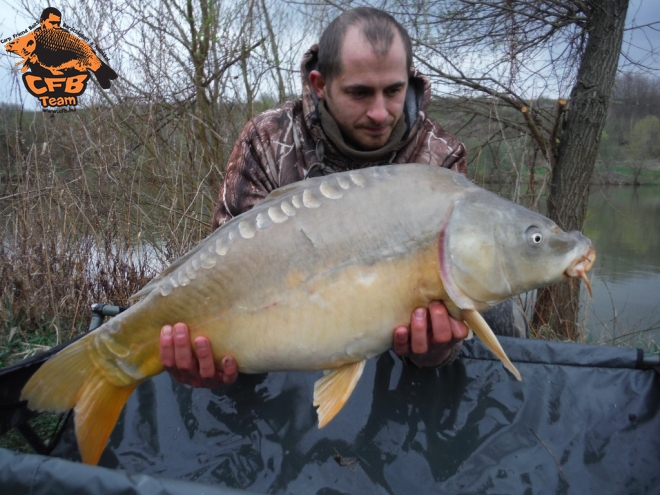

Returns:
310,26,408,151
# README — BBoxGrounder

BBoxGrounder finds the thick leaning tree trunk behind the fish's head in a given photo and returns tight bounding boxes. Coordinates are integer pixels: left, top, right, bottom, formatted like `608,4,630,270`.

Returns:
534,0,628,340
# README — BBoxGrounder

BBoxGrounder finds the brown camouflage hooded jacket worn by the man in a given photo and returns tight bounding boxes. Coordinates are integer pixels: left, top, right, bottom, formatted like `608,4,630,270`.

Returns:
213,45,467,229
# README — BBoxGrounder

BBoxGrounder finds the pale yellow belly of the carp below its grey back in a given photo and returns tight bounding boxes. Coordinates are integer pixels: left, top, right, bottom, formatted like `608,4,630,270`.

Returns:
189,242,446,373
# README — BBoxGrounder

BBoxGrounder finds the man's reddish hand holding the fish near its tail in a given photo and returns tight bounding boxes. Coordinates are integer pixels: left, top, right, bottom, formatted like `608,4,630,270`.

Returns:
160,323,238,388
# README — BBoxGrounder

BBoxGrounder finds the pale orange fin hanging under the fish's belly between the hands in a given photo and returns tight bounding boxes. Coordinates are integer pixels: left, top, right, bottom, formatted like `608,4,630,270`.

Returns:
314,360,367,428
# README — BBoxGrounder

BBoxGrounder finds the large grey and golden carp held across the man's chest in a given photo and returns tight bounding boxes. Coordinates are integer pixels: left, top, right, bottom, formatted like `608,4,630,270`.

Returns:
22,164,595,463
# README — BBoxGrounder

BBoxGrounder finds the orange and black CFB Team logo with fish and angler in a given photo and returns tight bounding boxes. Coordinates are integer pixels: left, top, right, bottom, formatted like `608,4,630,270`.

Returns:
2,7,117,111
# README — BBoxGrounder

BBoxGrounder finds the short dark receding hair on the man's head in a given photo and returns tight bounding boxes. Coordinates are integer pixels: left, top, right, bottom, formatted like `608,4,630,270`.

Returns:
318,7,412,84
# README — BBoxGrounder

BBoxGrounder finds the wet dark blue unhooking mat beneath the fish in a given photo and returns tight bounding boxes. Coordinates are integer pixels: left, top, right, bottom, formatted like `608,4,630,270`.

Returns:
0,337,660,495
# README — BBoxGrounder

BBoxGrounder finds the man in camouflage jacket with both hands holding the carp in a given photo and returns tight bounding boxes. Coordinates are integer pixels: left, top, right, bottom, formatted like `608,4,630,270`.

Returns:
160,7,516,387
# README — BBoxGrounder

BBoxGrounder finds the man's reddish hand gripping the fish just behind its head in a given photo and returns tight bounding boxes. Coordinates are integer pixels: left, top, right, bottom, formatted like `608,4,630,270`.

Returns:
393,301,468,367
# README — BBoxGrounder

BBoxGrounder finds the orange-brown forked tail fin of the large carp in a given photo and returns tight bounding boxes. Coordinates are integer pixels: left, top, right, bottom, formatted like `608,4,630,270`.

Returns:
21,337,137,464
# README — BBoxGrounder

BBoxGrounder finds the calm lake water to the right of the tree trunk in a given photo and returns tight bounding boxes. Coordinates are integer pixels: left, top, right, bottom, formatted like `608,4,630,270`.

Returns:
581,186,660,348
